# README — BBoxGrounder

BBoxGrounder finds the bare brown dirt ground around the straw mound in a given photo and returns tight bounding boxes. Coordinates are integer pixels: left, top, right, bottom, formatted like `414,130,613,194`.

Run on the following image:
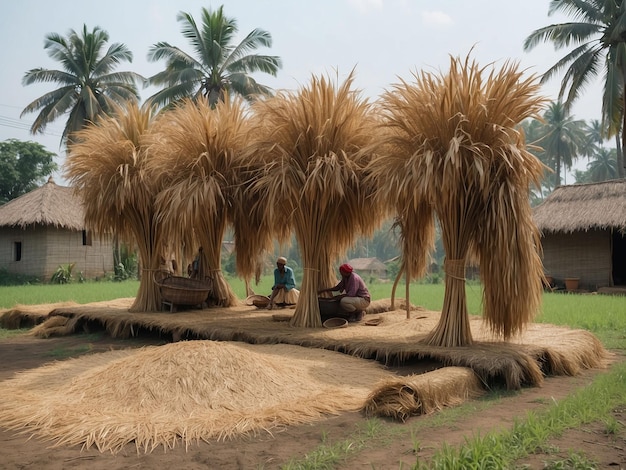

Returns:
0,335,626,470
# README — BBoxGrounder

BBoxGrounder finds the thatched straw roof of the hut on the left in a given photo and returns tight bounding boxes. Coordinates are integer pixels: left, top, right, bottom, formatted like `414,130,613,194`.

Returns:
0,177,85,230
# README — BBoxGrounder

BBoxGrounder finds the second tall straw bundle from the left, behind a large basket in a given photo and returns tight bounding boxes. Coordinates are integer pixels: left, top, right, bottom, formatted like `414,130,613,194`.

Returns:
149,99,251,307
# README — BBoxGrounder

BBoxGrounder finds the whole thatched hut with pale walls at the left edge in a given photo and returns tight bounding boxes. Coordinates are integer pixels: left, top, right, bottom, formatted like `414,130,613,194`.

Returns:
0,178,113,281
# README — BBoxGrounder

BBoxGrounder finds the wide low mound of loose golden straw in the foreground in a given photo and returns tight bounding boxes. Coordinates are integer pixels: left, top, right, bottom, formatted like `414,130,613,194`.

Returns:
0,341,391,453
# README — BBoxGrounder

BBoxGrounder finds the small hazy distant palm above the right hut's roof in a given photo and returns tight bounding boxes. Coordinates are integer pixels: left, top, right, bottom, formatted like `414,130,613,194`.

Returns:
536,101,588,186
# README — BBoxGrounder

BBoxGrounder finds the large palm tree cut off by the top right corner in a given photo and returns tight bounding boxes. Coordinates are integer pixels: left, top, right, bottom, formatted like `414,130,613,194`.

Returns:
524,0,626,178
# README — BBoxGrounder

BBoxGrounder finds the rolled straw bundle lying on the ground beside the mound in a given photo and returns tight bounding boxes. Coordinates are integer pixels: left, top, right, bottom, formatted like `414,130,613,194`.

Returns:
362,367,484,422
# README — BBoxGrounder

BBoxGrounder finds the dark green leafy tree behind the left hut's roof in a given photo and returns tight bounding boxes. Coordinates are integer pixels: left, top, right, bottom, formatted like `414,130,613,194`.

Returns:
0,139,57,204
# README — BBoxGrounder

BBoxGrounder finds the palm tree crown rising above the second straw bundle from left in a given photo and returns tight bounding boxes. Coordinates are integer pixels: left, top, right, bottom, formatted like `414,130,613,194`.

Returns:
148,6,282,107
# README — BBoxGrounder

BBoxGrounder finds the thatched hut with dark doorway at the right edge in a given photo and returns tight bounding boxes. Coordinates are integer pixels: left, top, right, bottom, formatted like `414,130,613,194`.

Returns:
534,180,626,290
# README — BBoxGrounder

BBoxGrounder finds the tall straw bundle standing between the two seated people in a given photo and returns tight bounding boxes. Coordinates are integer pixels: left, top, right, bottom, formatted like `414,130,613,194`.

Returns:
248,73,382,327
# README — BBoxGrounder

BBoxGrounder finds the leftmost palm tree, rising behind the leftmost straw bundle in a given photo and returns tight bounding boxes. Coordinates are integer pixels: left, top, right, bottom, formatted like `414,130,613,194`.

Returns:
22,25,144,147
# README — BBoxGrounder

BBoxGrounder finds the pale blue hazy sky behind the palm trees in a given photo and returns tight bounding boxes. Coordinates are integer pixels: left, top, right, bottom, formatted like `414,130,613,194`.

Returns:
0,0,601,177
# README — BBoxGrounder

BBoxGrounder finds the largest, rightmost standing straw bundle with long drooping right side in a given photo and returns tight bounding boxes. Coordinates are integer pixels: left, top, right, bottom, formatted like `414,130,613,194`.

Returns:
371,57,545,346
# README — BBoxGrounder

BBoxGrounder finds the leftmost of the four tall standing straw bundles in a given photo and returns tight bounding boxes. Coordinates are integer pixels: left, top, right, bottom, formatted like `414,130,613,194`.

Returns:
65,102,161,312
